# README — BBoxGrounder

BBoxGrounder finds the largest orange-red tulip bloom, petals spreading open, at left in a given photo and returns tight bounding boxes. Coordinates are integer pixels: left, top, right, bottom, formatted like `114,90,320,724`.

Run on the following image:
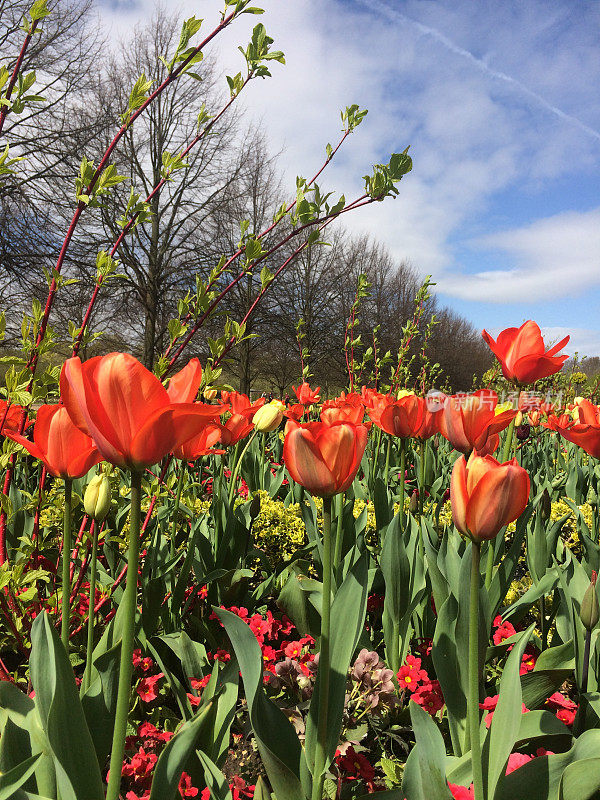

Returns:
60,353,222,470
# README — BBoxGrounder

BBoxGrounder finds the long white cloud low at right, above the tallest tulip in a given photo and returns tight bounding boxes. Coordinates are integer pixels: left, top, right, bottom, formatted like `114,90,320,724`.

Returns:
439,208,600,304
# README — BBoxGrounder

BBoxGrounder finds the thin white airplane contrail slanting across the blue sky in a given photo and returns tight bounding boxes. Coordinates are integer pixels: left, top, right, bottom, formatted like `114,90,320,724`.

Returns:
358,0,600,141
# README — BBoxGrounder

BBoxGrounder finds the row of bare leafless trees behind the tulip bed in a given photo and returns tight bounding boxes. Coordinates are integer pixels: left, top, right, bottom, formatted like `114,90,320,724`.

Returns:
0,0,490,394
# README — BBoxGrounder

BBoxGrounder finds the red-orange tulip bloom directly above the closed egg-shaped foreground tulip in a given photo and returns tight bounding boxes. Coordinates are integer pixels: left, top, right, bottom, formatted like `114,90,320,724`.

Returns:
439,389,517,453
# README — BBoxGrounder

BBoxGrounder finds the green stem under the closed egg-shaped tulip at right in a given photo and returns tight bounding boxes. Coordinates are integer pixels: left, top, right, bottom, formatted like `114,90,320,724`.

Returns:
467,542,484,800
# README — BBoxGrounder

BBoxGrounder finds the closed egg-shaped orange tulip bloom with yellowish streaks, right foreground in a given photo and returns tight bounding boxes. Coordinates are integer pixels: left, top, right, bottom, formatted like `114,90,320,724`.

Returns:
450,452,529,542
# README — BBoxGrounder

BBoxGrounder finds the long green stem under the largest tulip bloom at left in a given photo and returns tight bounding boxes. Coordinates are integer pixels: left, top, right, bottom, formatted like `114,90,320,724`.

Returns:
106,470,142,800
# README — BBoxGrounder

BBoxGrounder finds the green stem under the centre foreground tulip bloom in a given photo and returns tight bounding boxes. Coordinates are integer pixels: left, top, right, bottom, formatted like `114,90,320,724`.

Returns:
314,497,331,800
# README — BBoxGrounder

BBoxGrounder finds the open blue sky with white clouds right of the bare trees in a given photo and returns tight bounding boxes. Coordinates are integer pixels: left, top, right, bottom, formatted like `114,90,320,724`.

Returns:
97,0,600,355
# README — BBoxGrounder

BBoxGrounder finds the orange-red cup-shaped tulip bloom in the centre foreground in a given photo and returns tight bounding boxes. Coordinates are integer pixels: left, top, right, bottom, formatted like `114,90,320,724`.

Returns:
283,420,369,497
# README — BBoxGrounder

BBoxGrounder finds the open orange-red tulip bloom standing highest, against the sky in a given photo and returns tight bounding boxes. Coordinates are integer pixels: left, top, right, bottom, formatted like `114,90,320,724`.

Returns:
482,320,570,384
